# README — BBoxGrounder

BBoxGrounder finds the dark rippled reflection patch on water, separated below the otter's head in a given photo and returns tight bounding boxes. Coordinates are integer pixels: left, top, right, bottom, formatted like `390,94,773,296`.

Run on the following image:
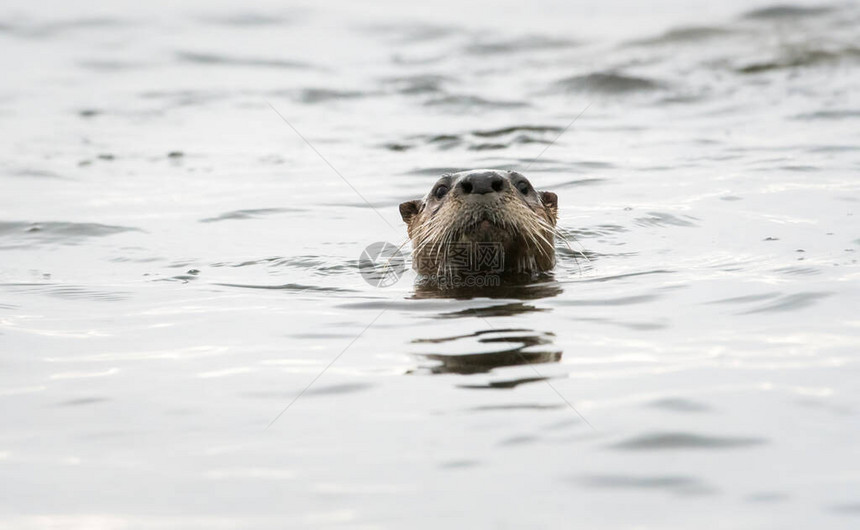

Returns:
412,329,562,376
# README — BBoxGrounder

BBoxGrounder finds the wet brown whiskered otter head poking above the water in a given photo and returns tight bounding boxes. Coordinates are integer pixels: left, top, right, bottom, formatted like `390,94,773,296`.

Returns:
400,169,558,277
